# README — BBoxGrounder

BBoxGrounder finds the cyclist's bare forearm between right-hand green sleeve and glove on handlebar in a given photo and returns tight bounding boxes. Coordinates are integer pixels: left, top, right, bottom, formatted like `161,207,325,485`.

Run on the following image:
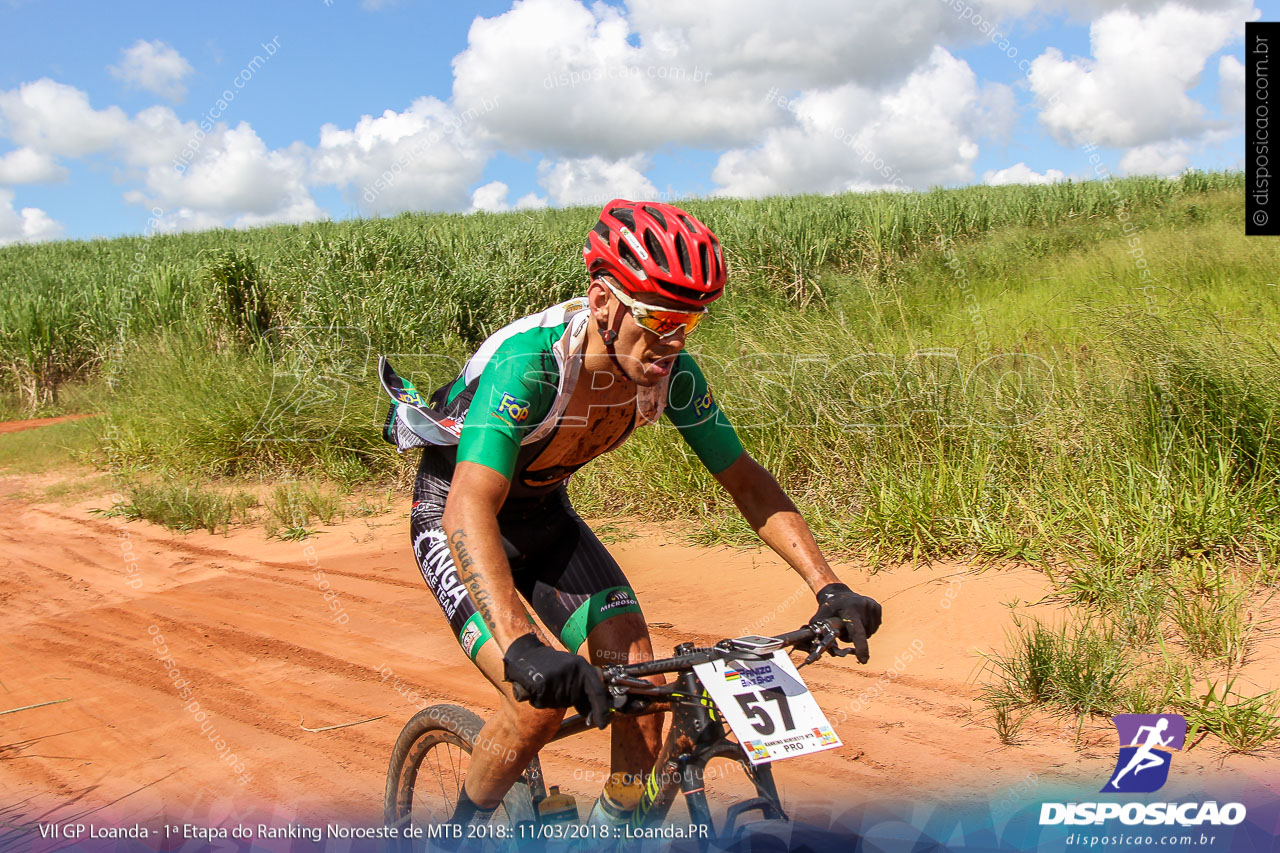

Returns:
716,451,840,592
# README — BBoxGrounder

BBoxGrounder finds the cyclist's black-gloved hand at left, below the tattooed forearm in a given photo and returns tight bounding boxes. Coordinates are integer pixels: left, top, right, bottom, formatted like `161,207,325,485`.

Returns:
502,634,609,729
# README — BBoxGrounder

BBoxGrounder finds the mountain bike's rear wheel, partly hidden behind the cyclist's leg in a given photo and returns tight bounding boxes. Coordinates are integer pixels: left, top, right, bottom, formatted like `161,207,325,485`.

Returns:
384,704,541,839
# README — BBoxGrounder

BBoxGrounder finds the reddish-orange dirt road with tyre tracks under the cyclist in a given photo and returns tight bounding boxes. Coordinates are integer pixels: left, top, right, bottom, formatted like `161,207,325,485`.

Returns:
0,466,1280,824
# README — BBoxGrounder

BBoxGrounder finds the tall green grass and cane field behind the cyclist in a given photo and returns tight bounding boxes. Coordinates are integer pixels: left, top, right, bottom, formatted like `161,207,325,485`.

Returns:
0,173,1280,744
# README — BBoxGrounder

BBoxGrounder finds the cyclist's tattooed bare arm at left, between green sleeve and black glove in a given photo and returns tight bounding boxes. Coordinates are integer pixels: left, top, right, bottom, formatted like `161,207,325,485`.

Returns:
440,462,532,649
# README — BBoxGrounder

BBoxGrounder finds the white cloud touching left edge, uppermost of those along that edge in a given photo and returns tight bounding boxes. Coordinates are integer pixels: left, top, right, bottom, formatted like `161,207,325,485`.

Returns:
0,77,129,158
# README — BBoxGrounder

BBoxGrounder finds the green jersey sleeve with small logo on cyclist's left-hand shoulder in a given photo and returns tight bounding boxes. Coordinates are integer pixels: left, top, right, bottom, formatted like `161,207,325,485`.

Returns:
458,347,559,480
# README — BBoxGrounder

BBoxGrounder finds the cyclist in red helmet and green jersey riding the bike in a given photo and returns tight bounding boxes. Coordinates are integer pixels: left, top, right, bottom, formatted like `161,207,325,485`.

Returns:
383,199,881,824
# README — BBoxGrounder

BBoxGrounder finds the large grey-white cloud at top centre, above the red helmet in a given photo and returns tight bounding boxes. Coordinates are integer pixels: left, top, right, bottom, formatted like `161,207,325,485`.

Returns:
453,0,993,159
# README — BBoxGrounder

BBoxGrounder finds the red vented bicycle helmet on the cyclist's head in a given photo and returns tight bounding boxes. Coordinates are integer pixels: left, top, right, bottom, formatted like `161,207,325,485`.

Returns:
582,199,726,307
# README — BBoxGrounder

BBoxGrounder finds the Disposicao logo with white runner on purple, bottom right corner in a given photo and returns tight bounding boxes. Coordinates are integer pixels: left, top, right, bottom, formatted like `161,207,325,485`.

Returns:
1039,713,1245,826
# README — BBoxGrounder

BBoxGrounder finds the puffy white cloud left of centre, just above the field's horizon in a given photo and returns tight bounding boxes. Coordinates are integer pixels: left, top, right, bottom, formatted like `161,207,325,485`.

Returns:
310,97,488,214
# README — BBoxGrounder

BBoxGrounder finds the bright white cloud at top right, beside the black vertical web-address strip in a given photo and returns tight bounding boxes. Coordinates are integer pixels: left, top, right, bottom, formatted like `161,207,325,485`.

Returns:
1029,0,1257,147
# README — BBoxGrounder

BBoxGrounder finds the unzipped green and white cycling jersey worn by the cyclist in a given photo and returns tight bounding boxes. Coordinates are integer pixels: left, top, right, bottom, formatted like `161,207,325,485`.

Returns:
380,298,742,497
